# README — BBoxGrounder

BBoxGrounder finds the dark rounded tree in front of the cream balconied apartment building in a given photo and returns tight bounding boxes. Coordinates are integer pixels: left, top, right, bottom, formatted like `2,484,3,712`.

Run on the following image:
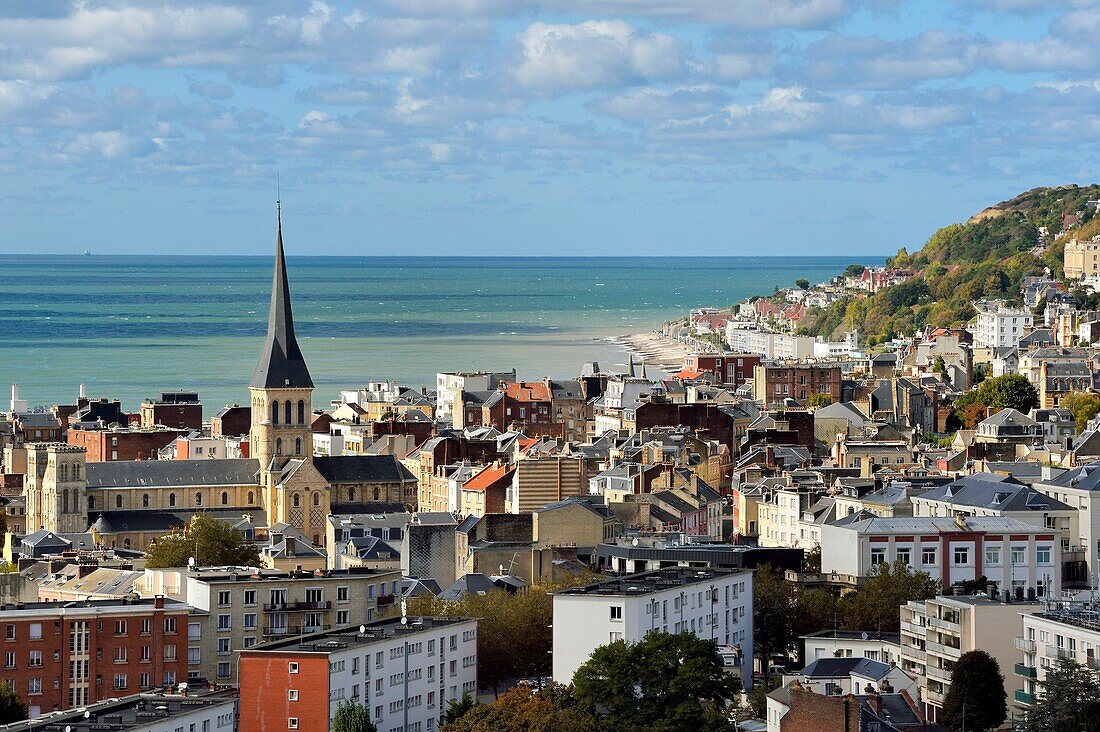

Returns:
941,649,1009,732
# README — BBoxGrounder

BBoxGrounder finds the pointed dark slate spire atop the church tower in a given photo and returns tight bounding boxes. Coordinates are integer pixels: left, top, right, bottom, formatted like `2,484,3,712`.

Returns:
249,201,314,389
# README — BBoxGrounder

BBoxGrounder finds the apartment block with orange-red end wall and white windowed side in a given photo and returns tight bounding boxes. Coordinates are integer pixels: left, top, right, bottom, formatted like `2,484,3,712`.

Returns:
240,618,477,732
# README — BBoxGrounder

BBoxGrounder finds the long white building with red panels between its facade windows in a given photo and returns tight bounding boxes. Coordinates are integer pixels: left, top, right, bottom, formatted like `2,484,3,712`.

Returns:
822,514,1062,599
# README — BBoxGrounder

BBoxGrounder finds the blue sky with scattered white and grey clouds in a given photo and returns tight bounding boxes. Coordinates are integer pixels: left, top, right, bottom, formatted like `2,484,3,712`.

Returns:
0,0,1100,256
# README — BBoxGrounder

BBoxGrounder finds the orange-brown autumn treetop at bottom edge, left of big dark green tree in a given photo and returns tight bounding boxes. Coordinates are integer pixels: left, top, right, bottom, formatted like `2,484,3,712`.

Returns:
440,686,603,732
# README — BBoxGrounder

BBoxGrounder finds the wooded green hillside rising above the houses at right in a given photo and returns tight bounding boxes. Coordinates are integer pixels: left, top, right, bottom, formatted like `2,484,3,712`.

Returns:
800,185,1100,346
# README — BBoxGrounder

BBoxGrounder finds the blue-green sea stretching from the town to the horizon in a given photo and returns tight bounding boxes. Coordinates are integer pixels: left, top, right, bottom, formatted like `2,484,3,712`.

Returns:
0,254,858,415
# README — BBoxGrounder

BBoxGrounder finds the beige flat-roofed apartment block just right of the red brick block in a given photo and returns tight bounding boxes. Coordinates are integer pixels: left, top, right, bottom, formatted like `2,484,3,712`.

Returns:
136,567,402,684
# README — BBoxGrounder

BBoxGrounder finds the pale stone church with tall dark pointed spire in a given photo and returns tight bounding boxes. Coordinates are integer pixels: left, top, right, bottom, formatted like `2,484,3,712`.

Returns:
24,210,417,550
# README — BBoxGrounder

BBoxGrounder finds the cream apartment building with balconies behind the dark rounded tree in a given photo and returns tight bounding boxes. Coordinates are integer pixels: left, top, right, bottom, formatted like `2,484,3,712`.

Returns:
901,596,1038,722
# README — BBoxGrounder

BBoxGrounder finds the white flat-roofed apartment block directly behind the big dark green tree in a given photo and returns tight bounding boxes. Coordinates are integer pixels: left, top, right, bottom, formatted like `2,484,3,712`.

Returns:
553,567,752,689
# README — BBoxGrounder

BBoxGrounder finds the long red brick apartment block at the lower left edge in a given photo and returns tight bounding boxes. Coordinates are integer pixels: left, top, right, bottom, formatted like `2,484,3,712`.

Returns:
0,598,188,718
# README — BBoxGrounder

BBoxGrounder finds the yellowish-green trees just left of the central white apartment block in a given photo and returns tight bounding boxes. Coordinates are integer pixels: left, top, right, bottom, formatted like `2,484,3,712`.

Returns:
408,575,595,693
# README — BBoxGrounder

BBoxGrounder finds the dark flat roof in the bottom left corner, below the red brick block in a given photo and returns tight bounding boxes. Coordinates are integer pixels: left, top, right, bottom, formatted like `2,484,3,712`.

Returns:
3,689,237,732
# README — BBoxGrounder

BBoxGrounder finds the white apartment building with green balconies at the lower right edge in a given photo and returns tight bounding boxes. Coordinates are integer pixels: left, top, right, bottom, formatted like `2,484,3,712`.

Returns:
1001,600,1100,709
